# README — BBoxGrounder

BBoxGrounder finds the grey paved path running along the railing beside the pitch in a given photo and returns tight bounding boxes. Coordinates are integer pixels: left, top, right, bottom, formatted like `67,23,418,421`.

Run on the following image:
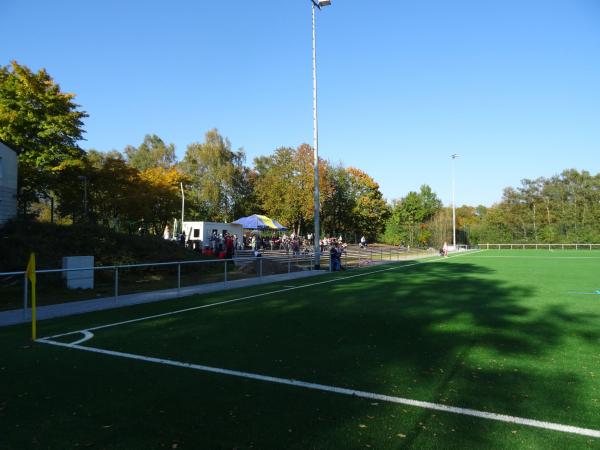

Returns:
0,270,329,327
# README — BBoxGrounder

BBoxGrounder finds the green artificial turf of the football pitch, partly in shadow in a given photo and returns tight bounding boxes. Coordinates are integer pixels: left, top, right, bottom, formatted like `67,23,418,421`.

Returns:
0,250,600,449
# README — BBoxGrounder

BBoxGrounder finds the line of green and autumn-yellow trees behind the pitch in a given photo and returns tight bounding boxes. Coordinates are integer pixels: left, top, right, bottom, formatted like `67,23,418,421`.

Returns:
0,62,600,247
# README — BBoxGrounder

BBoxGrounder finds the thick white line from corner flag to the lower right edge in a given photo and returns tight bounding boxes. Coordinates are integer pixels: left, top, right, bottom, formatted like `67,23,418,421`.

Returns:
37,338,600,438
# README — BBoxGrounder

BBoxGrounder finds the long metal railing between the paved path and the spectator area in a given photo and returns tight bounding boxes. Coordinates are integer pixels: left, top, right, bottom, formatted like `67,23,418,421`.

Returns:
0,247,436,314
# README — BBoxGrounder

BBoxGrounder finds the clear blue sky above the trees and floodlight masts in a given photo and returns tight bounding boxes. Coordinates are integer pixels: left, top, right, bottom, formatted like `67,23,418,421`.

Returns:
0,0,600,205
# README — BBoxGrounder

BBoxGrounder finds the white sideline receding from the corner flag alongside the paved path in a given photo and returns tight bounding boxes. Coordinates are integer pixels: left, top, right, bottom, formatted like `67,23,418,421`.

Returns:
44,250,482,339
